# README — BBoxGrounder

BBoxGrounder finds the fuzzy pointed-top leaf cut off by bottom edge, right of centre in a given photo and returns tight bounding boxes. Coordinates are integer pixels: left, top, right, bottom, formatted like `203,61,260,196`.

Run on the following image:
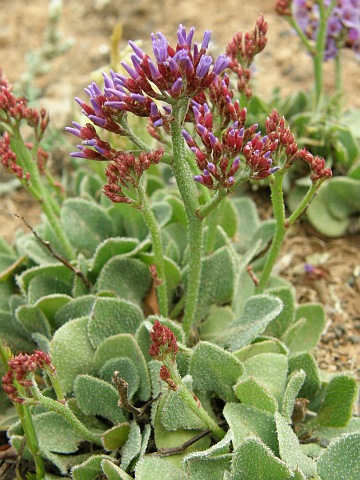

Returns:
231,438,292,480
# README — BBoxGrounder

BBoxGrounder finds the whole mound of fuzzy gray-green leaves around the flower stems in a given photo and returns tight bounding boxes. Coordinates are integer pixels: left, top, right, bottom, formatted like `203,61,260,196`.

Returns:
0,174,360,480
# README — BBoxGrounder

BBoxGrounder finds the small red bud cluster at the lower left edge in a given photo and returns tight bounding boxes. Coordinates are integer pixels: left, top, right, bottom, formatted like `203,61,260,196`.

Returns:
2,350,55,403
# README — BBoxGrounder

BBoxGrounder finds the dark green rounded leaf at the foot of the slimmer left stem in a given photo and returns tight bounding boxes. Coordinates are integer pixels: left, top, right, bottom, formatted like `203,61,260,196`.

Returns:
96,256,151,304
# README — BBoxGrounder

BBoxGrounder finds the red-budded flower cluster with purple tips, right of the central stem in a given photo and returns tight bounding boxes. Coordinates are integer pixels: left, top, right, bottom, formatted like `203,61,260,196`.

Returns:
183,95,278,189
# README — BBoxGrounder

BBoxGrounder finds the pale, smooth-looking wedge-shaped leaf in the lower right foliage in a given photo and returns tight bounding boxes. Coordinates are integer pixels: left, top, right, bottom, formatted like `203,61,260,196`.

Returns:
240,353,288,405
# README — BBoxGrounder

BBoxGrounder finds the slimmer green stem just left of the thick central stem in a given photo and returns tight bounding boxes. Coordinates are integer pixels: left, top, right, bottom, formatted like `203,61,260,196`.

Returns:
136,180,168,317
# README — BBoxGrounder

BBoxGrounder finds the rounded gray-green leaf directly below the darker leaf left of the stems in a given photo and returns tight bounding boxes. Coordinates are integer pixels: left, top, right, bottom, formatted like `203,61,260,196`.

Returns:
88,297,144,348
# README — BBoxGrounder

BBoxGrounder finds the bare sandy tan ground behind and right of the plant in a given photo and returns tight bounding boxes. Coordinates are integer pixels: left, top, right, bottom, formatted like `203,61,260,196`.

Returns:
0,0,360,374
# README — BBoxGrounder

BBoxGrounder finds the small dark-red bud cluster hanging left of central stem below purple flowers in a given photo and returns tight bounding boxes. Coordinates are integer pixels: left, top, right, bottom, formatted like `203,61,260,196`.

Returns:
104,148,164,203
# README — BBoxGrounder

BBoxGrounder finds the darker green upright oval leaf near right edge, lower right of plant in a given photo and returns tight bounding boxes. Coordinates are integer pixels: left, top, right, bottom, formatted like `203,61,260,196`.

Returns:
316,374,357,427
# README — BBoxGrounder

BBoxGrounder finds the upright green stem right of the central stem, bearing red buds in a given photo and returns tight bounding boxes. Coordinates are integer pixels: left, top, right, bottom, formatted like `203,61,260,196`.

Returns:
256,172,287,294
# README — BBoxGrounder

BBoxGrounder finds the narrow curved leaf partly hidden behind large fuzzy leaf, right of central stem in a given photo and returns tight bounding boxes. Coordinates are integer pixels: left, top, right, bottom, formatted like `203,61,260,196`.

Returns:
265,287,295,338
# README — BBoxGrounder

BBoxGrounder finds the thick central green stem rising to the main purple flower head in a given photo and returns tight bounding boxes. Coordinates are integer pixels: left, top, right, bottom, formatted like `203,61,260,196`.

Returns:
171,99,203,339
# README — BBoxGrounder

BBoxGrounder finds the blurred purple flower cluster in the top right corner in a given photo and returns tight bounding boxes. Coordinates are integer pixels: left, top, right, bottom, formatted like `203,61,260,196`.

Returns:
275,0,360,60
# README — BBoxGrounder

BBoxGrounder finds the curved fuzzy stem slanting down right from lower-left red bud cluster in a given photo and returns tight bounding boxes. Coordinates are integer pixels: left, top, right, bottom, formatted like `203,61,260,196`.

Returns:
29,378,102,445
